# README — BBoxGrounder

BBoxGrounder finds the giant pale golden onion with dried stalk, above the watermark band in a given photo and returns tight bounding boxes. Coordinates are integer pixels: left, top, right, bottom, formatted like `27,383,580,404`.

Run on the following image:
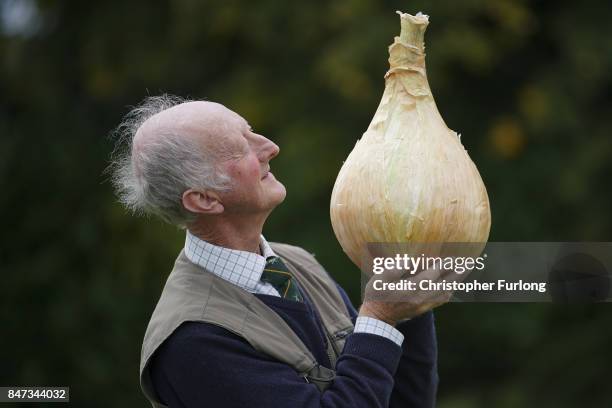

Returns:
330,12,491,267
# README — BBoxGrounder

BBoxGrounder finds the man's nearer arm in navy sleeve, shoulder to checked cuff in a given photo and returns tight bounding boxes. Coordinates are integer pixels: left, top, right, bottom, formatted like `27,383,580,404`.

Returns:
151,322,402,408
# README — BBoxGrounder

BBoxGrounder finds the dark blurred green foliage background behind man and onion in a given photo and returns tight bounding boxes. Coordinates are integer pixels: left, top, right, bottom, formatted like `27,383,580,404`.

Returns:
0,0,612,408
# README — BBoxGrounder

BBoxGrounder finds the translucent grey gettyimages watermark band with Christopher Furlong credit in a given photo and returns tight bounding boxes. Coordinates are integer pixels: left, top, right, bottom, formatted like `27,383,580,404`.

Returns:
362,242,612,302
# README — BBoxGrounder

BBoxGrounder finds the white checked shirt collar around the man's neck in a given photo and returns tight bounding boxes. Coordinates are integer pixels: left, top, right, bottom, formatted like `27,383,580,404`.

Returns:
185,231,276,292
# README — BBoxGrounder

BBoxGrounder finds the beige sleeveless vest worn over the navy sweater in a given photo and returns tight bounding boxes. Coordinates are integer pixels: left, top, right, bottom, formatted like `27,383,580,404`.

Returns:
140,243,353,408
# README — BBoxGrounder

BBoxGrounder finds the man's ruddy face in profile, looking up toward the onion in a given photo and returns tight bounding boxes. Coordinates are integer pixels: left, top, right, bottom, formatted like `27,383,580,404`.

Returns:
210,108,286,215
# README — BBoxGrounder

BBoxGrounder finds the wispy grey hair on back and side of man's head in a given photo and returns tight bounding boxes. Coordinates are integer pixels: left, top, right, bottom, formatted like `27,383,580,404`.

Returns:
107,94,230,228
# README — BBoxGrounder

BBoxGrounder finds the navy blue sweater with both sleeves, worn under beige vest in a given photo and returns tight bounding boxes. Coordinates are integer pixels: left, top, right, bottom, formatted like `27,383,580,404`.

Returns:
151,289,438,408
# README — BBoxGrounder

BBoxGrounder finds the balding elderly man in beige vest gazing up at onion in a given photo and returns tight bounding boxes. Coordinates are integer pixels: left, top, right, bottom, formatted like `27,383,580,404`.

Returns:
113,96,437,408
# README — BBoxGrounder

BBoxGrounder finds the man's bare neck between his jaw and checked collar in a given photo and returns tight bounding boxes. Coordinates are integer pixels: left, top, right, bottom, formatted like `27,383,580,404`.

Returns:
188,215,265,254
